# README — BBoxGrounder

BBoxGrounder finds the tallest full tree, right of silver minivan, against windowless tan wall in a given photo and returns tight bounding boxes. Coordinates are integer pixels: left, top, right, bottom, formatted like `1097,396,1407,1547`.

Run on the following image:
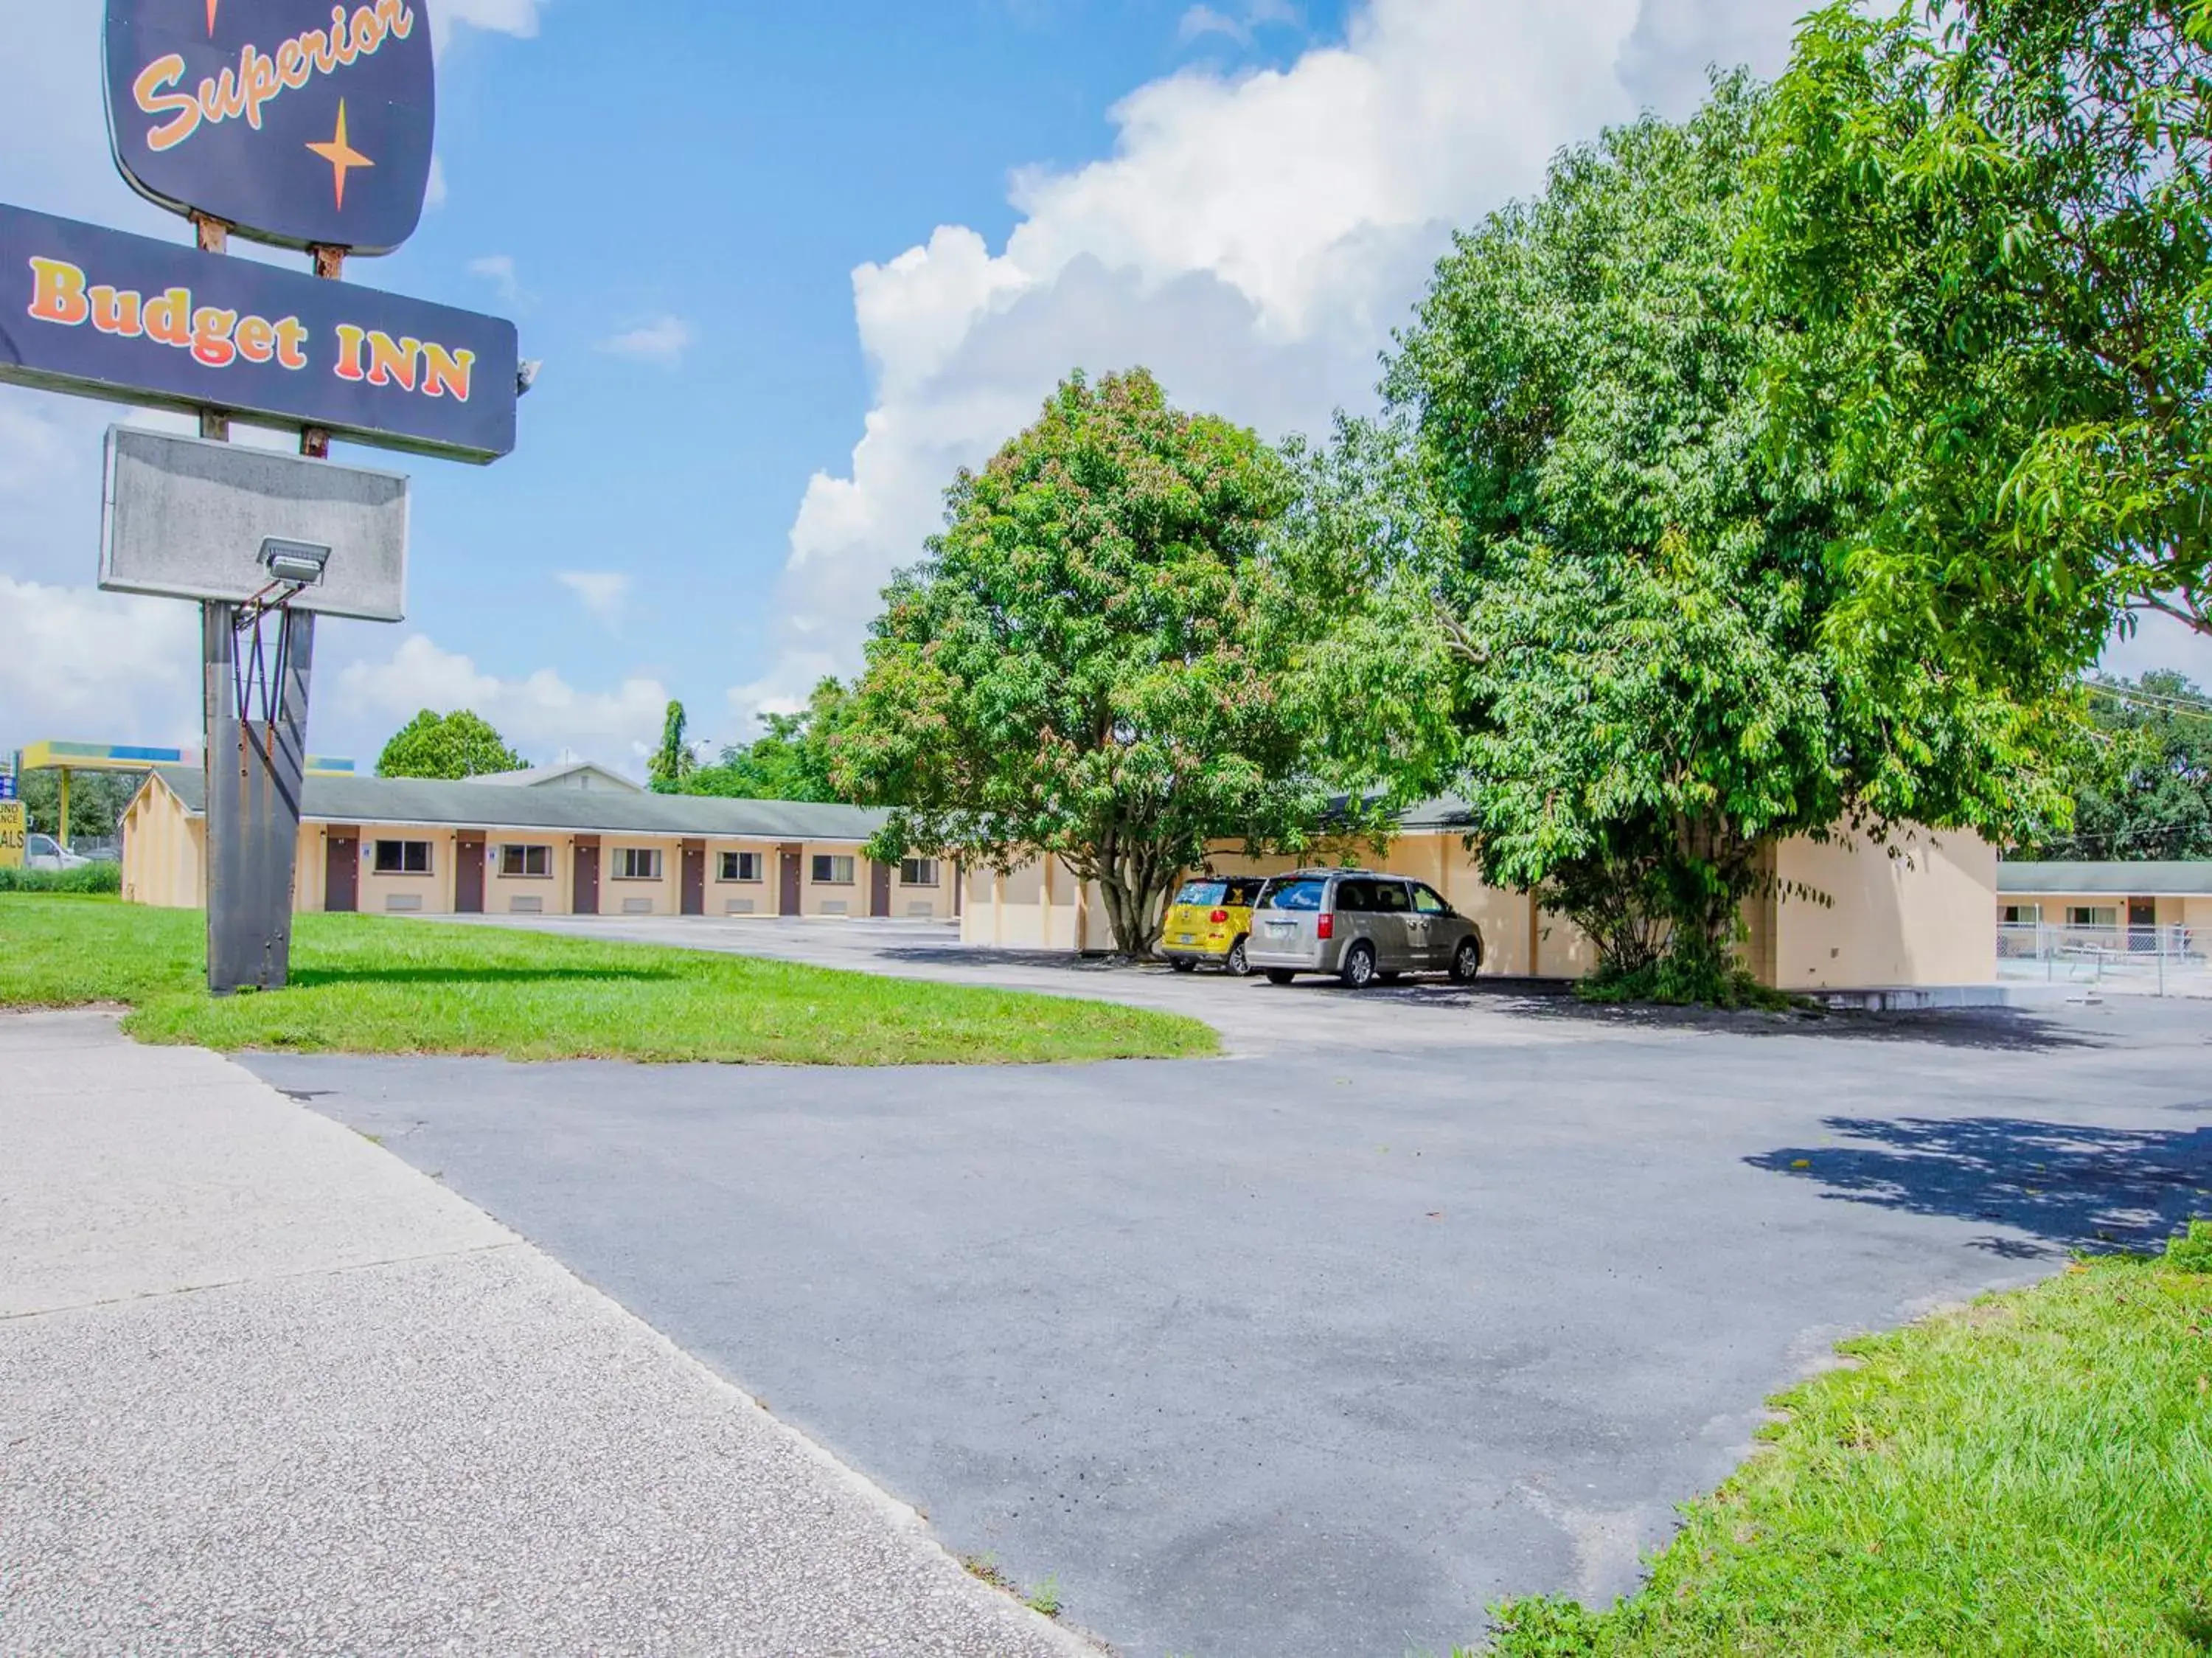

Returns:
1367,77,2048,996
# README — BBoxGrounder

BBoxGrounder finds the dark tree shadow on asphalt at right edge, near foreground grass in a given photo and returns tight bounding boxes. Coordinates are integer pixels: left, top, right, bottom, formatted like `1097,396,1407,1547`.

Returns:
1745,1118,2212,1260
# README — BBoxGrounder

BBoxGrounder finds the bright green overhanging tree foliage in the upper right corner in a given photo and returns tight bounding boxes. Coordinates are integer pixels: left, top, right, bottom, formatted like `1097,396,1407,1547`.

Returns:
1745,0,2212,677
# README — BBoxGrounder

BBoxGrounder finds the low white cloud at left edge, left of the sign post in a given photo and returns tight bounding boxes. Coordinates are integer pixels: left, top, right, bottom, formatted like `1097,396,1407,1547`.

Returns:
0,575,199,748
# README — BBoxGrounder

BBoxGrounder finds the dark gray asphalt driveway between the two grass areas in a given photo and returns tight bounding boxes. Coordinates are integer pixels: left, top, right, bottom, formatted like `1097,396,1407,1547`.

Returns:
252,969,2212,1658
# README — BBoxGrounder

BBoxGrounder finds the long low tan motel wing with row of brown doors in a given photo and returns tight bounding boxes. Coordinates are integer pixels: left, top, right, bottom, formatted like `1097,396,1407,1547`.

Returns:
122,763,960,921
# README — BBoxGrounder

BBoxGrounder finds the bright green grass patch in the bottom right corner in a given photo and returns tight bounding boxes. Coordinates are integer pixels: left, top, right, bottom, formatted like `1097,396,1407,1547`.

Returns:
1493,1222,2212,1658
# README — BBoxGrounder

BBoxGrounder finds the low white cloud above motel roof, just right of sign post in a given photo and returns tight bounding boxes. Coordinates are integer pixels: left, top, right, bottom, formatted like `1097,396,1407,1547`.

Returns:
336,633,668,755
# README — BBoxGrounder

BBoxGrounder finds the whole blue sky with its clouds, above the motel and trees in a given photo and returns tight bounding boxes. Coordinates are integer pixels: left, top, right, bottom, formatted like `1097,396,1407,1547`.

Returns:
0,0,2212,766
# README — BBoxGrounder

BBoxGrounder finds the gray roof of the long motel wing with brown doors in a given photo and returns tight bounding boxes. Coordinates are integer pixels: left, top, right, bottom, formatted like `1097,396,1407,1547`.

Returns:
157,766,887,842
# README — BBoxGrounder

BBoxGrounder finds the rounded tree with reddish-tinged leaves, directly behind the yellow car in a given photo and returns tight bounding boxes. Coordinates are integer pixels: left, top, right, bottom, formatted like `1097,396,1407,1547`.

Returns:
836,370,1321,954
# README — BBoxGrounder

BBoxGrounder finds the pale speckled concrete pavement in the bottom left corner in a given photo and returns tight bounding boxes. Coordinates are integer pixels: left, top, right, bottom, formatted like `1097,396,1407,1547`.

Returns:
0,1014,1088,1658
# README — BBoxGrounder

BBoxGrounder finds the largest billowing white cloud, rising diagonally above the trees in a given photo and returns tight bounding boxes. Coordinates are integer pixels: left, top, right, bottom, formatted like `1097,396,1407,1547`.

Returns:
752,0,1798,701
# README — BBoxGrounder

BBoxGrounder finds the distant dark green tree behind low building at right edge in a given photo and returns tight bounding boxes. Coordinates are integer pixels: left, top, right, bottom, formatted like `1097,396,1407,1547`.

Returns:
2028,670,2212,864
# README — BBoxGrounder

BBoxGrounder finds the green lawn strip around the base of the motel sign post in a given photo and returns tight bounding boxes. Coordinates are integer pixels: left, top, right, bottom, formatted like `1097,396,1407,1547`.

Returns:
0,895,1219,1065
